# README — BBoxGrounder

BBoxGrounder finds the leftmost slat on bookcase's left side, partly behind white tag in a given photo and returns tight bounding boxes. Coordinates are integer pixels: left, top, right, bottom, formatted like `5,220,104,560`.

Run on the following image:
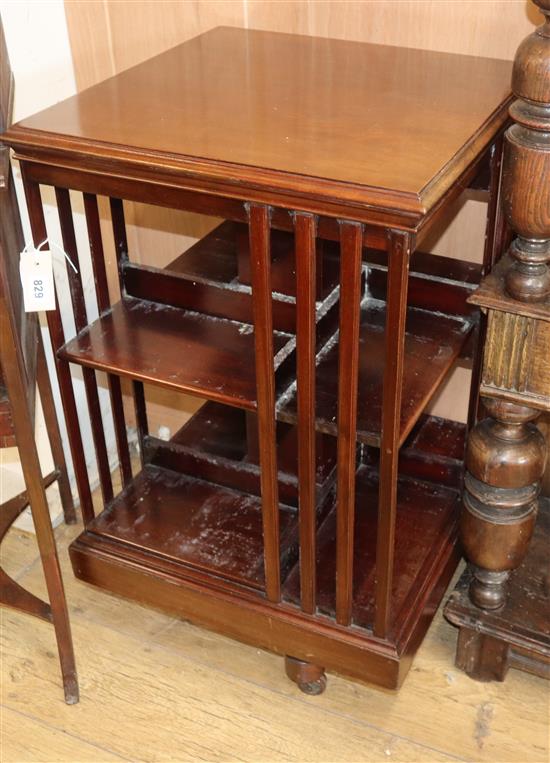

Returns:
21,163,94,524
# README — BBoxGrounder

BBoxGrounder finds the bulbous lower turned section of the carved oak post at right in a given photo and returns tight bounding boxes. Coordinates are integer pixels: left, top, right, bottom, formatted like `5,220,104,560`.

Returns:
461,398,546,609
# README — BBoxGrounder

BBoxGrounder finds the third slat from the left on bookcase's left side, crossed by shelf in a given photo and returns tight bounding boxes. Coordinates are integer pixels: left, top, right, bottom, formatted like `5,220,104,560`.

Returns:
83,193,132,485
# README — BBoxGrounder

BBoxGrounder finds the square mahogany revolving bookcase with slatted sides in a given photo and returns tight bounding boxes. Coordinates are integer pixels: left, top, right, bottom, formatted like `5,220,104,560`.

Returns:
4,28,511,693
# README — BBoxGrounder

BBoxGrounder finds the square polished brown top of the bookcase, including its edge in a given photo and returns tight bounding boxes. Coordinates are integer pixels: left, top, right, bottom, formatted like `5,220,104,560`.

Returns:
5,27,511,219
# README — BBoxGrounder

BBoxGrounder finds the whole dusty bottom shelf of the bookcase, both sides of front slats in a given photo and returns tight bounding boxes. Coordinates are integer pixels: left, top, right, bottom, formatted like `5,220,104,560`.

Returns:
83,465,458,616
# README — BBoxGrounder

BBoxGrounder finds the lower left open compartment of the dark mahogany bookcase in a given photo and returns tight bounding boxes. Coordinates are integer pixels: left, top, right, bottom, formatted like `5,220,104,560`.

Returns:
83,402,336,590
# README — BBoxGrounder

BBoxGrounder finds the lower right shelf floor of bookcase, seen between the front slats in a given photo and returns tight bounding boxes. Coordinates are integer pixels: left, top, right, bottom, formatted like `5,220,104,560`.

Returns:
284,466,460,643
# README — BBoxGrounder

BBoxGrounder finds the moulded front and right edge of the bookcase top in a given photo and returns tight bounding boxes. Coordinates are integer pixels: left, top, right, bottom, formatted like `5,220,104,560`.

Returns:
0,104,513,231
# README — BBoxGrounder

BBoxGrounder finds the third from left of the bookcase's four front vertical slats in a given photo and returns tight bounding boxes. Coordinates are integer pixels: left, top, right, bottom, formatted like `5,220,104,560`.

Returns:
336,222,363,625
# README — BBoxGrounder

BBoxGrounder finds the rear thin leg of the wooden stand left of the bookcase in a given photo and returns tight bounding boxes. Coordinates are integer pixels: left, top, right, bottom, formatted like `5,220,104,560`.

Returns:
36,331,76,525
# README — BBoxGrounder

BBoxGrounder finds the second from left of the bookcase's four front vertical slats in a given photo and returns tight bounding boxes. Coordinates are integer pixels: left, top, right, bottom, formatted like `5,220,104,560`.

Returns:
294,212,317,614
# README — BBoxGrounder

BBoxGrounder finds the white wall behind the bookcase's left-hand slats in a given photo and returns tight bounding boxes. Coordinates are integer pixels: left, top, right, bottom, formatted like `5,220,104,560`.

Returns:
0,0,114,530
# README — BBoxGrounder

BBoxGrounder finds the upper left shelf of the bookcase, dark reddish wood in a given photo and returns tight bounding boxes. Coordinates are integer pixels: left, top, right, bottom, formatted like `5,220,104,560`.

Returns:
59,298,290,410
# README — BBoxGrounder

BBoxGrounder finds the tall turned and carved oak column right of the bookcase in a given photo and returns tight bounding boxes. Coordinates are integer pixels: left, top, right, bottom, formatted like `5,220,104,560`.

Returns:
461,0,550,609
